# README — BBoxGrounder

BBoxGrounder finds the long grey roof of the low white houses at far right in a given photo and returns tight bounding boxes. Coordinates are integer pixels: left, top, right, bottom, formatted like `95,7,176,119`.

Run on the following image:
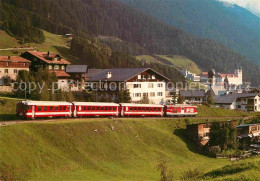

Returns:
213,93,258,104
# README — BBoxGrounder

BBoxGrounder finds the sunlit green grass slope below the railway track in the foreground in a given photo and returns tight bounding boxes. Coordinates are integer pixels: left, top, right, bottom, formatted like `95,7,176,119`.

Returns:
0,119,229,180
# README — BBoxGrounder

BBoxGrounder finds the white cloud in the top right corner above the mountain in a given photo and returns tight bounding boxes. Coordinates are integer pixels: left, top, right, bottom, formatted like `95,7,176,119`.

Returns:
219,0,260,14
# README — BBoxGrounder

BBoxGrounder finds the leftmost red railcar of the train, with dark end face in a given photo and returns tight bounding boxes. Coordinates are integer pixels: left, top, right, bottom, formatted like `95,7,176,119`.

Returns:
16,101,72,119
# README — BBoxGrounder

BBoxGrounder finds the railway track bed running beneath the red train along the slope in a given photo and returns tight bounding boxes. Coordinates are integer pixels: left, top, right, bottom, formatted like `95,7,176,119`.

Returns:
0,116,252,127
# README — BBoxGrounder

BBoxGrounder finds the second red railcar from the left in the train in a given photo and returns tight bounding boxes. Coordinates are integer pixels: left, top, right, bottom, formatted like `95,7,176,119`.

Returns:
73,102,119,117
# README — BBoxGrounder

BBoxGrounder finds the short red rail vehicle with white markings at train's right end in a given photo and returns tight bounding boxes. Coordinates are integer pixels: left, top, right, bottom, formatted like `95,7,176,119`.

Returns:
164,105,198,116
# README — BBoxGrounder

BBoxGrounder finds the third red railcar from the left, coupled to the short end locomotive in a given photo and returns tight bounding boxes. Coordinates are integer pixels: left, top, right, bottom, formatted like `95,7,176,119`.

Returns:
120,103,164,117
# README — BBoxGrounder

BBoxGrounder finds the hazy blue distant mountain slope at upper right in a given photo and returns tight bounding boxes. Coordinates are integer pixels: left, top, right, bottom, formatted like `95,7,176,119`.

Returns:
121,0,260,64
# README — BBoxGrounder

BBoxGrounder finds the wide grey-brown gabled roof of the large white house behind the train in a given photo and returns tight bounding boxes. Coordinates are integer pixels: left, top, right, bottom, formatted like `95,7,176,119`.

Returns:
86,68,170,82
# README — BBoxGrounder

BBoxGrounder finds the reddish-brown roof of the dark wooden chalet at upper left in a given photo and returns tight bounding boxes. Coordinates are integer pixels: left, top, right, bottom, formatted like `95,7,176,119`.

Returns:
25,51,70,65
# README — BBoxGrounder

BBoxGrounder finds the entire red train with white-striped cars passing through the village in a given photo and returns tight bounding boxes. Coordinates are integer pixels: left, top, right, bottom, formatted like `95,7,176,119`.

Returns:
16,101,198,119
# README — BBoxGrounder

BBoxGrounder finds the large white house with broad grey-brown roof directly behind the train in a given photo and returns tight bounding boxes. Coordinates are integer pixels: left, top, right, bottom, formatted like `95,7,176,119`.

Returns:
86,68,169,104
